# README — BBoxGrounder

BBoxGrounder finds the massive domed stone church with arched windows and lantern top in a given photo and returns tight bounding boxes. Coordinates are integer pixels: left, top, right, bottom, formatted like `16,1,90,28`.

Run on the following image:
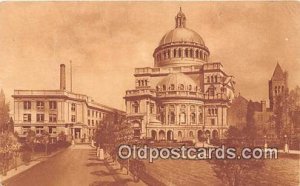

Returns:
124,10,234,141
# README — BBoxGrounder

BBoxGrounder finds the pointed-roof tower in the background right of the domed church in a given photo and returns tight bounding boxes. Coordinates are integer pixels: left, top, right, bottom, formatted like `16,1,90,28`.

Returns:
269,63,288,110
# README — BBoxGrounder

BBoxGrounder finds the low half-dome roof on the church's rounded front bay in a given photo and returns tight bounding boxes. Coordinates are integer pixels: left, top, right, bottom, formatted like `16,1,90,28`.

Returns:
157,73,196,89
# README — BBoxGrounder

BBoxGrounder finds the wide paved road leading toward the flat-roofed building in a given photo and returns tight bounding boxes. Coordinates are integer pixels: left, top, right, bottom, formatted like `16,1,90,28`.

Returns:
4,145,145,186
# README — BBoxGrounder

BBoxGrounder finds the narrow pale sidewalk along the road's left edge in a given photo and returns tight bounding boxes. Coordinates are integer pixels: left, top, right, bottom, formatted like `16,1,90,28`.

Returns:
0,149,65,183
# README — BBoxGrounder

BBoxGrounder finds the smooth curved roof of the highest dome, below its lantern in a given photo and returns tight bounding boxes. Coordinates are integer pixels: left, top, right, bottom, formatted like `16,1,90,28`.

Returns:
159,27,205,45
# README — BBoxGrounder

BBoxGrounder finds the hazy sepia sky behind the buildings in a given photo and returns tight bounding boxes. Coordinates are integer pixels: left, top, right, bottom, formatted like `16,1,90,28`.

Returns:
0,2,300,110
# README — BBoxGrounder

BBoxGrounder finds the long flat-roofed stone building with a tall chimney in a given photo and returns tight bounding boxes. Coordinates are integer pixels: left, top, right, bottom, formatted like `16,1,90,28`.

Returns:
12,64,125,142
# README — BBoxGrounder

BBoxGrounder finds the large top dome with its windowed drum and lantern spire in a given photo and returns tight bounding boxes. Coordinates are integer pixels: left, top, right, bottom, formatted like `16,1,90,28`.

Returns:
153,9,210,67
